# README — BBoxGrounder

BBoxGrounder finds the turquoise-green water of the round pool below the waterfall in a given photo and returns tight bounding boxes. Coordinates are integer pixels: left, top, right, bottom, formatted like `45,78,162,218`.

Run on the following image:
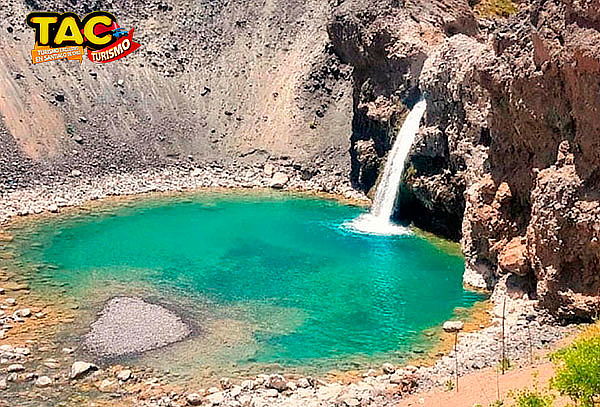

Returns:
15,194,482,368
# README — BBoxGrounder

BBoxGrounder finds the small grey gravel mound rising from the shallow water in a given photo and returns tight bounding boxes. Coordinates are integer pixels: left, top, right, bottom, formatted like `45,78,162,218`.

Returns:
83,297,191,357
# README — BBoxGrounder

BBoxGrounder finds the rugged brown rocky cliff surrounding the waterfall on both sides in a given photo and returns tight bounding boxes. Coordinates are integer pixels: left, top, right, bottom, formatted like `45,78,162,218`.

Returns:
329,0,600,319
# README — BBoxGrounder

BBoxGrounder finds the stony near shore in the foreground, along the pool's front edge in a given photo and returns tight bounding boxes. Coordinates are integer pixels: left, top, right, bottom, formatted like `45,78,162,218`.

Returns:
0,280,576,407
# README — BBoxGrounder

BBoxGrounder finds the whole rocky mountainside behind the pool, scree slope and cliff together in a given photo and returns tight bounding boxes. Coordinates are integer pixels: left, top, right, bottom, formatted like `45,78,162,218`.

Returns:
0,0,600,319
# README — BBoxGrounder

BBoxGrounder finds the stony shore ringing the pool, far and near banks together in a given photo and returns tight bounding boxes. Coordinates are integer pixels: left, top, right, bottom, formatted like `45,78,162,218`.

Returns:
0,166,574,407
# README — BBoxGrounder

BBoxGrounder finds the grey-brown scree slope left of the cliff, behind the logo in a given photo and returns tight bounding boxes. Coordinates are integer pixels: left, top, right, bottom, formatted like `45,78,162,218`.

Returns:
0,0,351,188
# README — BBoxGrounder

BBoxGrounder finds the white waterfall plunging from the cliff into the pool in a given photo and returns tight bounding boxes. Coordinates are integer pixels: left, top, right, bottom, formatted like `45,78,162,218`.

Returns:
349,99,427,235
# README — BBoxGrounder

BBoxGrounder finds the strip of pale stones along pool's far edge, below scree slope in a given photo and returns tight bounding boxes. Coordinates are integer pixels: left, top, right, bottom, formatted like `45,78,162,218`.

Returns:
0,163,367,223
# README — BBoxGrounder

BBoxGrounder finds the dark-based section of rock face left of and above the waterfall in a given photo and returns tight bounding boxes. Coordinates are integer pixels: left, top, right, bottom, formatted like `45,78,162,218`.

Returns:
328,0,477,198
